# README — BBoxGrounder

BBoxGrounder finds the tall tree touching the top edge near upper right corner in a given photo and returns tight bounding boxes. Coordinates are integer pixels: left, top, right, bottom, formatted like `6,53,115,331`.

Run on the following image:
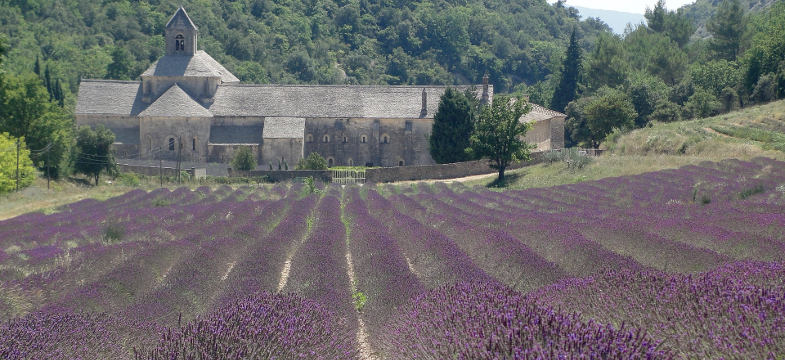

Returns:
706,0,744,61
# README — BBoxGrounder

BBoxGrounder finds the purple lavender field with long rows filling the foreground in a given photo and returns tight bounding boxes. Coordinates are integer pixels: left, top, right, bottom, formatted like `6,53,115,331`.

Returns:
0,158,785,359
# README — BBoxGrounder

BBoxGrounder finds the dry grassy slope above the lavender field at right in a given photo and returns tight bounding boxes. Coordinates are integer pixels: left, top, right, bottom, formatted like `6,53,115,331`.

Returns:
466,100,785,189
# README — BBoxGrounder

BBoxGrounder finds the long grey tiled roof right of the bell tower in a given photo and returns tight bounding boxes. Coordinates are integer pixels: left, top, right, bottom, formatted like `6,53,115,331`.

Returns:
210,84,493,118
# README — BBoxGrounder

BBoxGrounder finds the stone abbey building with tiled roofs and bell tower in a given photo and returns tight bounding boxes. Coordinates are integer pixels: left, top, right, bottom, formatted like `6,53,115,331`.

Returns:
75,8,565,168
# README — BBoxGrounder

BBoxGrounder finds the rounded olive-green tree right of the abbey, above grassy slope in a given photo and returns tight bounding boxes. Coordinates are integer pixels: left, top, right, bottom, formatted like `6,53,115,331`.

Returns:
584,87,638,148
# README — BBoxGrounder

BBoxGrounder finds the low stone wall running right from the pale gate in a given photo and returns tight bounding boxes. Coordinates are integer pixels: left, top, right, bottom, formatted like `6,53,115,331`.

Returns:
365,152,543,183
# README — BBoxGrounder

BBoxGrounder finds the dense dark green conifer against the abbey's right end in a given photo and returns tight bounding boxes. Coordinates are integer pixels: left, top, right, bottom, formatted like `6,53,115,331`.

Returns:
428,88,474,164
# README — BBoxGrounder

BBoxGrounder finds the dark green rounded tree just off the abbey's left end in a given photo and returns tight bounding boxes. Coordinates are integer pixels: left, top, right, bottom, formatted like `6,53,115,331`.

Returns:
74,125,115,185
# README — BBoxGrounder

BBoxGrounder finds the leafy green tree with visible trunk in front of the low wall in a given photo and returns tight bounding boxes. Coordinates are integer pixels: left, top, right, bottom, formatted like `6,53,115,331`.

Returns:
468,95,531,185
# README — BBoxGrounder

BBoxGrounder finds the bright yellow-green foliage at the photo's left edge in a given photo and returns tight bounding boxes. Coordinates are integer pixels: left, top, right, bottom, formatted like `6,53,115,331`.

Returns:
0,132,35,193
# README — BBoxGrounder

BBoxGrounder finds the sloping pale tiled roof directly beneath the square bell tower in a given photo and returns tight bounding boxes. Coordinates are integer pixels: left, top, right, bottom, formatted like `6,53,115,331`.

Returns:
140,50,240,83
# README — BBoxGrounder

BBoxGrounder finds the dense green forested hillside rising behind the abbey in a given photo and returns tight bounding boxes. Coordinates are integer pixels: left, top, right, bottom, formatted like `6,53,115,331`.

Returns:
0,0,607,98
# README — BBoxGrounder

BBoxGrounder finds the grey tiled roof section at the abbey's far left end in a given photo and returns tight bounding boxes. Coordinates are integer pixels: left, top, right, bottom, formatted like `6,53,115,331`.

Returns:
75,79,147,116
